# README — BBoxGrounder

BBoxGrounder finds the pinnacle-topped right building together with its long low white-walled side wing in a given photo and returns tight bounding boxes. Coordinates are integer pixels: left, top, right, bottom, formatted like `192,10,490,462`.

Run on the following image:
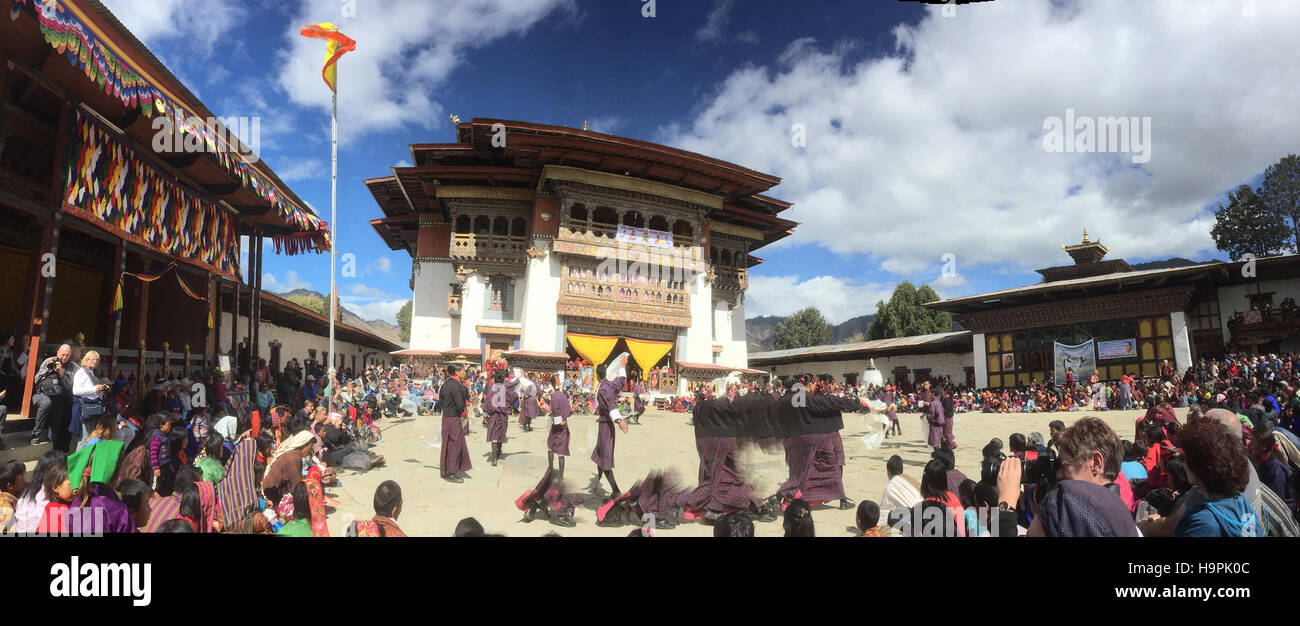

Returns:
749,230,1300,390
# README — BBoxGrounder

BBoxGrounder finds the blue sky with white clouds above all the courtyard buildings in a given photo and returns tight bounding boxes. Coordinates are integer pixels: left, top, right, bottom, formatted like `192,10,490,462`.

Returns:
98,0,1300,327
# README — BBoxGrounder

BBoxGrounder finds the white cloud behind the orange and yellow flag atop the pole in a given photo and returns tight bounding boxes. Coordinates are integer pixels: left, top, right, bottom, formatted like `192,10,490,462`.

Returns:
277,0,577,143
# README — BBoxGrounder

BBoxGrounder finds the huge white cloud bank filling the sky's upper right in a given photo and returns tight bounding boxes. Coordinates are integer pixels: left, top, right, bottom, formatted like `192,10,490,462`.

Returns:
659,0,1300,274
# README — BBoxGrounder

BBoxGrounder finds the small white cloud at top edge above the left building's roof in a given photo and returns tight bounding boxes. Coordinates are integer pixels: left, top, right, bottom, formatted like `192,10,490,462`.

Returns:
104,0,246,56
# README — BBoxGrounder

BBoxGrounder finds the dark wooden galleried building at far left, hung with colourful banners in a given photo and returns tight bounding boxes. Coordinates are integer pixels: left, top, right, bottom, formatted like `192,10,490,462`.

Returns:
0,0,340,416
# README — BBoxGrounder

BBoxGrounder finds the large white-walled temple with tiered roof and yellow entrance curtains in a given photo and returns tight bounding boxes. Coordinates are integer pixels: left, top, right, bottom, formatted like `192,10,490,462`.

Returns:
367,118,796,392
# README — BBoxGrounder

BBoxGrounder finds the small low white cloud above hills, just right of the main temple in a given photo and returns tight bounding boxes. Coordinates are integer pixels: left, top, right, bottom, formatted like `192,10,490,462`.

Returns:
745,274,894,323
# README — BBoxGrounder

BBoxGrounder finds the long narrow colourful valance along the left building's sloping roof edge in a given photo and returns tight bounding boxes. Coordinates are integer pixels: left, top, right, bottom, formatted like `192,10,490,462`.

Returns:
10,0,332,252
